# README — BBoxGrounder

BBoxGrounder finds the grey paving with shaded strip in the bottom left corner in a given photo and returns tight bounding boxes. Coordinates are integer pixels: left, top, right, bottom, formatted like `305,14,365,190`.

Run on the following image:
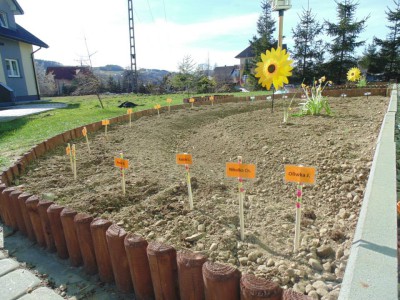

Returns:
0,223,135,300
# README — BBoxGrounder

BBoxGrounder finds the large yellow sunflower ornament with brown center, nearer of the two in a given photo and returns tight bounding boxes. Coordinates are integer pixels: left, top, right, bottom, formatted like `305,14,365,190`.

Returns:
255,47,293,90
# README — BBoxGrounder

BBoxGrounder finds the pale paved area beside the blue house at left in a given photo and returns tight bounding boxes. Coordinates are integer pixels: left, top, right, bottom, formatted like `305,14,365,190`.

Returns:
0,103,67,122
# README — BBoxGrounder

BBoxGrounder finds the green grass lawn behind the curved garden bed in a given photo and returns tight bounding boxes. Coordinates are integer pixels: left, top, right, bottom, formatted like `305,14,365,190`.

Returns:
0,91,268,170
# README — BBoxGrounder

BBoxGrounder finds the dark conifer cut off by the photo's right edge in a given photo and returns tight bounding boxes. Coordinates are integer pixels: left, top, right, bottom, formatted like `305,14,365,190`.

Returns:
375,0,400,79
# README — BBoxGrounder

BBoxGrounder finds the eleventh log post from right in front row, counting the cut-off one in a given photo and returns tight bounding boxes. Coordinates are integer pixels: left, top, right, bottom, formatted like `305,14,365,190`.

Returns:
47,204,69,259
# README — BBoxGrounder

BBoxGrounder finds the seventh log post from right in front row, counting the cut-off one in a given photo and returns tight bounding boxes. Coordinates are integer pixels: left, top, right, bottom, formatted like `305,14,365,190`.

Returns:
106,224,133,293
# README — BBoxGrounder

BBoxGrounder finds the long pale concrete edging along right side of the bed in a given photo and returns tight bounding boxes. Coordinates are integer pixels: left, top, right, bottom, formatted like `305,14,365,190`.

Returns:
339,85,399,300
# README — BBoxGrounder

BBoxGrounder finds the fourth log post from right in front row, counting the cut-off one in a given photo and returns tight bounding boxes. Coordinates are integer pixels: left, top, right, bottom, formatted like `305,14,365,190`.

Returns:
176,250,207,300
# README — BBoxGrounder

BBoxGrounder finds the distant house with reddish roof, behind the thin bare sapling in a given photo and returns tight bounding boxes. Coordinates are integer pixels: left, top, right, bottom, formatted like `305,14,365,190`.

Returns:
46,66,90,95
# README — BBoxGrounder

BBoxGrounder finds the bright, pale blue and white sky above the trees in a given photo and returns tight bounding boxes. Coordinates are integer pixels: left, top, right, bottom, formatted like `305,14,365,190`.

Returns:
16,0,394,71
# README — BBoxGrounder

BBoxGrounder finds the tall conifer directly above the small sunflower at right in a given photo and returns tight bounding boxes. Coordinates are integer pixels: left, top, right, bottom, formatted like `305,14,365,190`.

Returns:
325,0,369,84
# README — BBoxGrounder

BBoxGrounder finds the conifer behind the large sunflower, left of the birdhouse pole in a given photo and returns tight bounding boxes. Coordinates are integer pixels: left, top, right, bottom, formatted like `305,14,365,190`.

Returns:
246,0,277,88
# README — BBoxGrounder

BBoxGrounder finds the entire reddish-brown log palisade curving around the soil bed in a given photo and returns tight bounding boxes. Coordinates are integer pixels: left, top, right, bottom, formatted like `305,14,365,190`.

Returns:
0,88,394,300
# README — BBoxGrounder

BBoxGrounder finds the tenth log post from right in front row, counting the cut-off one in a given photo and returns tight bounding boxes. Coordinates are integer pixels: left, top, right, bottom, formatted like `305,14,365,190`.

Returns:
60,207,82,267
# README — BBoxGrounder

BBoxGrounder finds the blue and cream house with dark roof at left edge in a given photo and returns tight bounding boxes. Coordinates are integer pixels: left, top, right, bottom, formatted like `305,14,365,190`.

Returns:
0,0,49,106
